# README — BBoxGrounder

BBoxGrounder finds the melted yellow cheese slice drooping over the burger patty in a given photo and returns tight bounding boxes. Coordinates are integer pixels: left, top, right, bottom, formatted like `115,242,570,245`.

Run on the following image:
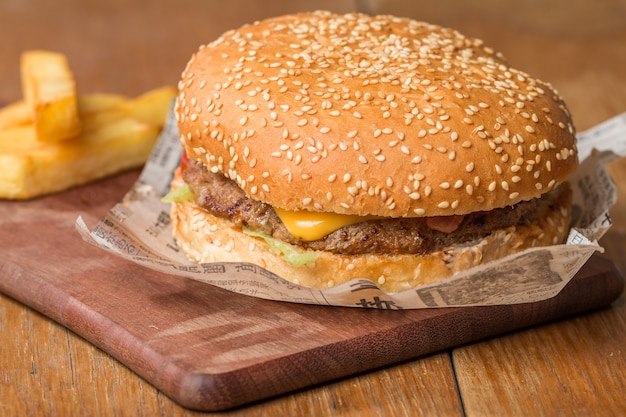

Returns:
274,207,380,241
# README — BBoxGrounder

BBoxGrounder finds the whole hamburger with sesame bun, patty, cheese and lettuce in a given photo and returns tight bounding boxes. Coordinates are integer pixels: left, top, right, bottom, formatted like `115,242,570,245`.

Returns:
168,11,578,292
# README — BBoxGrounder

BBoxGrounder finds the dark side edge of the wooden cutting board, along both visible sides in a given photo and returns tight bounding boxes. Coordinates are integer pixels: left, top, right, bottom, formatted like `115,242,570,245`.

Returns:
0,250,624,411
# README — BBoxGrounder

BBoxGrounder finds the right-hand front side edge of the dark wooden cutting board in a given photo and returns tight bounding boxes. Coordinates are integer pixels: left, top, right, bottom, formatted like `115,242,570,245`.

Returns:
176,255,624,411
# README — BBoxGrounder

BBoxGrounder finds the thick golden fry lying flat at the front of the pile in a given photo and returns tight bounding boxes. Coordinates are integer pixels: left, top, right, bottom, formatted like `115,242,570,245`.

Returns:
0,117,160,200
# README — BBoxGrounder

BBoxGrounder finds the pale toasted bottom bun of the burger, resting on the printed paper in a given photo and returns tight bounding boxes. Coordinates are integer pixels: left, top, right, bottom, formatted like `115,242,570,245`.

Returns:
171,188,571,293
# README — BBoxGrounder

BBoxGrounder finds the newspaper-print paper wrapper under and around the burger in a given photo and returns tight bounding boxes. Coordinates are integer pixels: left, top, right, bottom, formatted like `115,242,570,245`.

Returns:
76,108,626,309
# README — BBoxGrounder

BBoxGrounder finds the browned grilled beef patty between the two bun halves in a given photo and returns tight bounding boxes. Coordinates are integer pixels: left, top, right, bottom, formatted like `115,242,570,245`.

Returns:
183,160,571,255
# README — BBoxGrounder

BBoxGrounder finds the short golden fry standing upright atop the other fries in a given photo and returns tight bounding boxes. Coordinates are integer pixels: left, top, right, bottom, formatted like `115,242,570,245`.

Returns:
20,50,80,142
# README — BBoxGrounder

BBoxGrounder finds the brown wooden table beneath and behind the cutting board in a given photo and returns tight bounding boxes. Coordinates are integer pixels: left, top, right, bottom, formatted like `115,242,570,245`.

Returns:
0,0,626,416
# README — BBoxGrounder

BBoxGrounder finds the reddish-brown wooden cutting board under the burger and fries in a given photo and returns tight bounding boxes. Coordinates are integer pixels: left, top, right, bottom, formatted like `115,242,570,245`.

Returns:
0,172,624,410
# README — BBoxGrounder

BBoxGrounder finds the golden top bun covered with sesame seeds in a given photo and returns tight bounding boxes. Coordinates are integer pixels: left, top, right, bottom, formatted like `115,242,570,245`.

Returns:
176,12,578,217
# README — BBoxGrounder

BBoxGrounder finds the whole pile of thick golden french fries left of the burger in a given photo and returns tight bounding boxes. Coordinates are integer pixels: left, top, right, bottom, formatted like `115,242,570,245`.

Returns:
0,47,176,199
